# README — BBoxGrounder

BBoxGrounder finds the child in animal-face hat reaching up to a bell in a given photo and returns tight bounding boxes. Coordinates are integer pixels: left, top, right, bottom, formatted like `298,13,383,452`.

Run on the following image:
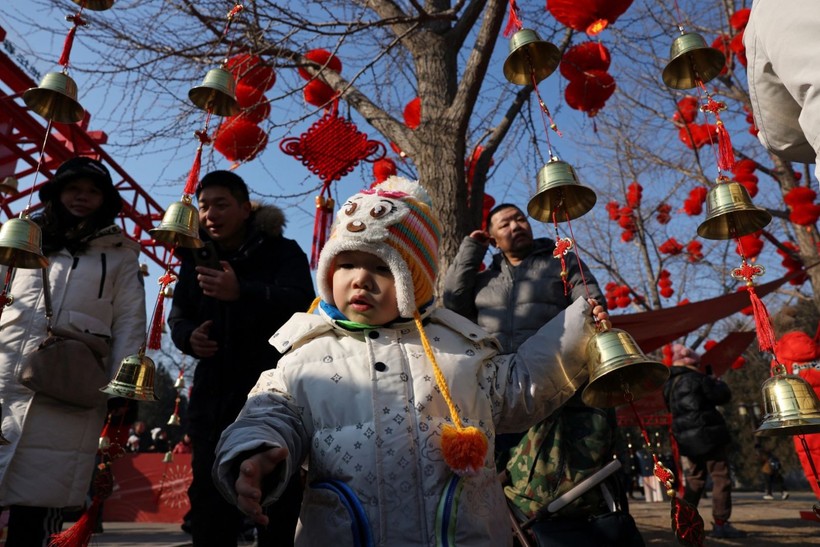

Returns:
214,177,607,547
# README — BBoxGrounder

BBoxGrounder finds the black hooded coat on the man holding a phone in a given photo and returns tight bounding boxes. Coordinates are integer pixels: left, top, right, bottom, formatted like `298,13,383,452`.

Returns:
168,205,314,443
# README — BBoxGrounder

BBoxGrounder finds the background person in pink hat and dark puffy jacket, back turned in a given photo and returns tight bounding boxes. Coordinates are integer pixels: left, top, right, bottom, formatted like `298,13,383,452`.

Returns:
663,344,746,538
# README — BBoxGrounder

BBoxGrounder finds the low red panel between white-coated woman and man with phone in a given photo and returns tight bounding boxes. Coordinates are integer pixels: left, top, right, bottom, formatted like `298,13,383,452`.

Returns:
103,454,193,523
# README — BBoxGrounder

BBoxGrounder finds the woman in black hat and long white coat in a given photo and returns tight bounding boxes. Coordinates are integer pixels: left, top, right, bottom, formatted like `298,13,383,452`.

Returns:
0,157,145,547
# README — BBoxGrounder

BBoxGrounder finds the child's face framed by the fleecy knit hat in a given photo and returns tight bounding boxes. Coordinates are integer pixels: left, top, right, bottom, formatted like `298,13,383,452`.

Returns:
333,251,399,325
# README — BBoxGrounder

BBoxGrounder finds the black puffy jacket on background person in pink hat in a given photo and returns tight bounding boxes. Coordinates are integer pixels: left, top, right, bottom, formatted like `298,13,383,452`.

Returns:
663,366,732,457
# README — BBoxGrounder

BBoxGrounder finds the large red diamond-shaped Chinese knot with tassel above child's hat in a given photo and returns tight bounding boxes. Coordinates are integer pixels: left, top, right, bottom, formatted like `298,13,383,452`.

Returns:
279,102,385,268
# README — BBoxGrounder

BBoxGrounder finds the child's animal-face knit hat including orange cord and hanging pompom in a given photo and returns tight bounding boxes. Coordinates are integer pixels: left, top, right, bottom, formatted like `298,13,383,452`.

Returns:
311,176,489,475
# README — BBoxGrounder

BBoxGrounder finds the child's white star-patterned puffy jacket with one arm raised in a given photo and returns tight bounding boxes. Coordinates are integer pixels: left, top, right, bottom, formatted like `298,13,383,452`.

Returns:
214,300,593,547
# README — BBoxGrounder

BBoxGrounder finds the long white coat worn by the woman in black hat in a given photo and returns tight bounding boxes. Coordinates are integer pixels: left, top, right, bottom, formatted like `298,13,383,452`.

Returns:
0,225,145,507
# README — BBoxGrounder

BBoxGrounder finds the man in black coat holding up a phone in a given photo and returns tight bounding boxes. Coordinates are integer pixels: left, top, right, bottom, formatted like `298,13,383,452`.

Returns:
168,171,314,547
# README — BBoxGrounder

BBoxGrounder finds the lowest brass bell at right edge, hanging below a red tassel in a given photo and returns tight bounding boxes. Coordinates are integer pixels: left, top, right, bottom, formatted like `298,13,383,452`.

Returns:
755,365,820,437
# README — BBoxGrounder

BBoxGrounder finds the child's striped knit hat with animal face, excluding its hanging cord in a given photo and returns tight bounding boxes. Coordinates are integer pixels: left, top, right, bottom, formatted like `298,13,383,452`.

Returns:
316,177,441,317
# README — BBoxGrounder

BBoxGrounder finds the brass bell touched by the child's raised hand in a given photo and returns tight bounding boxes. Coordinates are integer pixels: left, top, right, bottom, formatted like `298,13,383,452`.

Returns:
581,328,669,408
